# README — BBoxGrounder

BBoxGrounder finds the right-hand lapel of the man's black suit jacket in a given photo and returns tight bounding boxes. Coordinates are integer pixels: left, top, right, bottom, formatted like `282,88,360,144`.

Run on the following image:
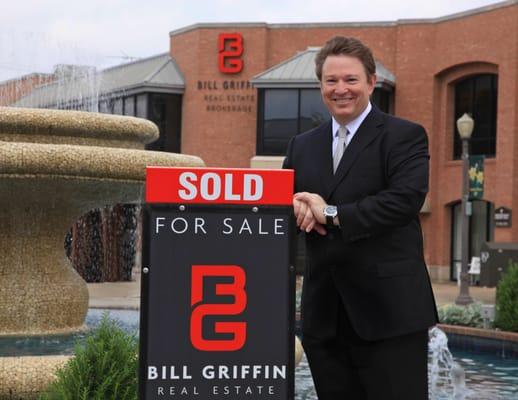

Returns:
327,105,383,198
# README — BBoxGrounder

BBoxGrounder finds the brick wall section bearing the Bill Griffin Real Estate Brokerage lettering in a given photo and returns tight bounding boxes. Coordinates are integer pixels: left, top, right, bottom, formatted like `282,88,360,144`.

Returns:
171,27,267,167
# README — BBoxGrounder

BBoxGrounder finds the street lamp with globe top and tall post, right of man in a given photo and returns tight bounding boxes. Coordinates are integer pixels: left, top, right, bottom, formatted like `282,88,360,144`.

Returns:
455,113,475,305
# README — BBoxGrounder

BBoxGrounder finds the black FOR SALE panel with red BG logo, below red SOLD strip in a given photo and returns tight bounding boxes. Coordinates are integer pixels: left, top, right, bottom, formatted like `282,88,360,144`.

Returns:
140,205,295,400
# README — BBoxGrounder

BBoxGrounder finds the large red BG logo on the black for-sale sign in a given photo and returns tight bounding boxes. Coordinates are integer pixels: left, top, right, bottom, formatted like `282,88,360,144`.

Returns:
191,265,247,351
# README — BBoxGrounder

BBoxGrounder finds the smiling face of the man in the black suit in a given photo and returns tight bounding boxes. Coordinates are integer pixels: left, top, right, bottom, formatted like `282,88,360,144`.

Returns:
320,55,376,125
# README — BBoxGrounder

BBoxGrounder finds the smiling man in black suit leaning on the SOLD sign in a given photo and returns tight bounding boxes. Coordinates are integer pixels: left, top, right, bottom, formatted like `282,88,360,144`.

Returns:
284,37,437,400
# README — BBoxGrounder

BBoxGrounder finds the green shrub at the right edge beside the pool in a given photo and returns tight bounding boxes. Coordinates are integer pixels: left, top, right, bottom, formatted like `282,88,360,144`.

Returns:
495,263,518,332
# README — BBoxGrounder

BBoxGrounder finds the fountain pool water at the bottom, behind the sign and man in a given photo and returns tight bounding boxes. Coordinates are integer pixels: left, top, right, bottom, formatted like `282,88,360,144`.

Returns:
0,309,518,400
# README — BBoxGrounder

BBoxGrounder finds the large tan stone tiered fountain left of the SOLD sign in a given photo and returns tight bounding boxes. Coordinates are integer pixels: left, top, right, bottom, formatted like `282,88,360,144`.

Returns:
0,107,203,398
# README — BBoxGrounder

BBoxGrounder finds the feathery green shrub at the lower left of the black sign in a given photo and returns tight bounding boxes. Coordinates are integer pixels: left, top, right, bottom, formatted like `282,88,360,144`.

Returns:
40,314,138,400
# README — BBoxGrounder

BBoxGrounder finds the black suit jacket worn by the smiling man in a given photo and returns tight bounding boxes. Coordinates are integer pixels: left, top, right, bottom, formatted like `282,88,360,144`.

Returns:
284,106,437,340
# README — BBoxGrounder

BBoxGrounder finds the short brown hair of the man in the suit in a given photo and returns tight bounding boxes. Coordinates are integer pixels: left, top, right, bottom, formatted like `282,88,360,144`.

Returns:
315,36,376,81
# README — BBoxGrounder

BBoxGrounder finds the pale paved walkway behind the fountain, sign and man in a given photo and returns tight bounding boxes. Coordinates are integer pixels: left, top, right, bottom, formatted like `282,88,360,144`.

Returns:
88,277,495,309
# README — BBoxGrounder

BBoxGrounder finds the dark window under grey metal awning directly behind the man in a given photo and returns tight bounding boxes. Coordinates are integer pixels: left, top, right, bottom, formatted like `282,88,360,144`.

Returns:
257,88,392,155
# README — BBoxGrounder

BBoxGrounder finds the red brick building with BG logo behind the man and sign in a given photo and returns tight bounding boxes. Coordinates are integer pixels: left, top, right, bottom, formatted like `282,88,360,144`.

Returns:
4,0,518,280
